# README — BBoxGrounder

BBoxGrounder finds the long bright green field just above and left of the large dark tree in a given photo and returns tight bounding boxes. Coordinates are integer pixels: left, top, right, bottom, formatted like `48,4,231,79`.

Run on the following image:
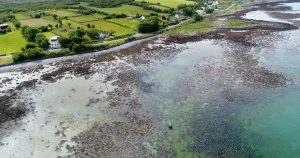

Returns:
93,5,155,16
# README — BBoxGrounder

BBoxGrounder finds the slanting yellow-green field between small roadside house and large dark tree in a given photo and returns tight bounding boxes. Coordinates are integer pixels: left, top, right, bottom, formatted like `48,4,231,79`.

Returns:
85,20,135,36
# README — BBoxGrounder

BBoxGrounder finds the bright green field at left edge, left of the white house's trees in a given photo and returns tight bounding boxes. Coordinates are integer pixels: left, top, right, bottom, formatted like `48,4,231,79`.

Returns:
0,30,27,55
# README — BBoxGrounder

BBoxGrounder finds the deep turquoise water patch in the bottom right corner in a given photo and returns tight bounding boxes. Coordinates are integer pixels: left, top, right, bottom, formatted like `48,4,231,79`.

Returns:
241,87,300,158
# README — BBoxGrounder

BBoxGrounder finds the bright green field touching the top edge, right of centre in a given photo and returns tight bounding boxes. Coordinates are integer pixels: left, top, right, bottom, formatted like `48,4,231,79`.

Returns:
137,0,195,8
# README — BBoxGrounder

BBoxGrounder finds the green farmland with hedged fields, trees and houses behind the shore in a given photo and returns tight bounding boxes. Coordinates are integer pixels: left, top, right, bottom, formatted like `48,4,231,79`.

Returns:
0,0,245,65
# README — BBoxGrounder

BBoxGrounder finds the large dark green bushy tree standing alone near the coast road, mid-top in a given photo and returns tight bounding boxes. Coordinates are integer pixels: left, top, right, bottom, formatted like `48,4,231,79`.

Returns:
138,16,159,33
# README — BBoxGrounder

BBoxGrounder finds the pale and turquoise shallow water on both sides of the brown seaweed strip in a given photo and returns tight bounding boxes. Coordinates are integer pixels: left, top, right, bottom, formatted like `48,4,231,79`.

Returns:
0,1,300,158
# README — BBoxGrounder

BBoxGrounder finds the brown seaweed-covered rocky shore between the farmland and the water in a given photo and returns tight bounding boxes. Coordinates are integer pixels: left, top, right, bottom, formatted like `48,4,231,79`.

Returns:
0,0,297,158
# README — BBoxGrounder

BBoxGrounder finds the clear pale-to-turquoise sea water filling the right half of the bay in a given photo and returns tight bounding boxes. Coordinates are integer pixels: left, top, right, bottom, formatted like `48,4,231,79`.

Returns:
142,31,300,158
